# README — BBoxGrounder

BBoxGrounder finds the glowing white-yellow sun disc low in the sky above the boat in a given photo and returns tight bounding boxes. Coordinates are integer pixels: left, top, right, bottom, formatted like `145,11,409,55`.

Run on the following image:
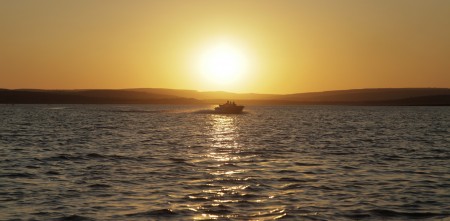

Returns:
198,42,249,85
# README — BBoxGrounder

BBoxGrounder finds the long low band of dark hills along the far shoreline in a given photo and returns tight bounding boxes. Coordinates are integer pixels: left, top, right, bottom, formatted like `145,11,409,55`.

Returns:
0,88,450,106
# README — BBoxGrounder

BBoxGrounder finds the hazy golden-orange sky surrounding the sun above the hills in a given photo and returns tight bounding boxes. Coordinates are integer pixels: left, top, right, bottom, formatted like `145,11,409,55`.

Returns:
0,0,450,93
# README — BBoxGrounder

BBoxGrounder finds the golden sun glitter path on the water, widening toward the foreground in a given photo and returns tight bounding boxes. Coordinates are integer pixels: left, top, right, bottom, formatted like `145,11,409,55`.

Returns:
188,114,286,220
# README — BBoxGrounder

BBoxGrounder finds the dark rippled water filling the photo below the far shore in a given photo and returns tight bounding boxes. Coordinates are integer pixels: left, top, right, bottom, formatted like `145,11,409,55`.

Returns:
0,105,450,220
